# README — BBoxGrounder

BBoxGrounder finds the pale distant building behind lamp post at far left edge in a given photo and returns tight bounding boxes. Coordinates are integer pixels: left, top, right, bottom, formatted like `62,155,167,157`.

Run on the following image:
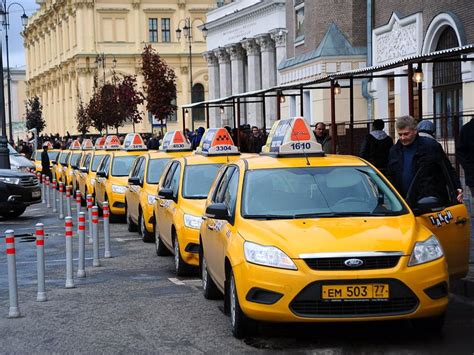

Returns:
3,68,27,142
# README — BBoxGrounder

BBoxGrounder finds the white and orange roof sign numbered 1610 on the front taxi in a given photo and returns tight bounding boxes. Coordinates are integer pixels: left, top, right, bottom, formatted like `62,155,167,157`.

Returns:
262,117,324,156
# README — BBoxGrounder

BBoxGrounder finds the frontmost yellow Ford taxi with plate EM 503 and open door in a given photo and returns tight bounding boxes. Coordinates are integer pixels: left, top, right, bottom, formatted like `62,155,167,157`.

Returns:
200,118,470,338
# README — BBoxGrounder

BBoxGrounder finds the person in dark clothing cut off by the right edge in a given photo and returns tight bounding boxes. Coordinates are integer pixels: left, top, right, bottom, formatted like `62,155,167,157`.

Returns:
456,119,474,198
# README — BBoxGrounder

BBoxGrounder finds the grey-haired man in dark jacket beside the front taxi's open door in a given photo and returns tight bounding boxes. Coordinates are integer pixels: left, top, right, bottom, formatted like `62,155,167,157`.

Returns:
386,116,463,205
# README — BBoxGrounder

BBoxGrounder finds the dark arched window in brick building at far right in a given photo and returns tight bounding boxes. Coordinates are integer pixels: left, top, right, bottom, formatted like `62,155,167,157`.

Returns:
433,26,462,137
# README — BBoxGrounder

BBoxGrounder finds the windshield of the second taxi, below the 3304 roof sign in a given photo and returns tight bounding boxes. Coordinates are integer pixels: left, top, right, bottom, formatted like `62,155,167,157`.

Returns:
183,164,222,199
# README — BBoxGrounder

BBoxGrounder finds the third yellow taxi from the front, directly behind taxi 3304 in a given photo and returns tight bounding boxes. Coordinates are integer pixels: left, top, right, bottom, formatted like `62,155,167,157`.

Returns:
125,131,192,242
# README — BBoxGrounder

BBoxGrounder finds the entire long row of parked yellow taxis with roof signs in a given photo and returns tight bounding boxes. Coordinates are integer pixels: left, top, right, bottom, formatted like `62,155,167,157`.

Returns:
30,118,470,337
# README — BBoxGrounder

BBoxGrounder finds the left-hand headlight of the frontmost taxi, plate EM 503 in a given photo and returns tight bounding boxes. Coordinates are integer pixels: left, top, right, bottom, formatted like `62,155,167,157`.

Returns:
244,242,298,270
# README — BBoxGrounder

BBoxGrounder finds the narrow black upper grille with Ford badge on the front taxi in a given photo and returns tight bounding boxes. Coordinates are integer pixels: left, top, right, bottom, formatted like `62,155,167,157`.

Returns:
304,255,400,271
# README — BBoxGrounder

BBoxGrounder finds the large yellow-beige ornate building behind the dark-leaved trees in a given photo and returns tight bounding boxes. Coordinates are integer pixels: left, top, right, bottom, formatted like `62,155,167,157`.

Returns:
23,0,216,134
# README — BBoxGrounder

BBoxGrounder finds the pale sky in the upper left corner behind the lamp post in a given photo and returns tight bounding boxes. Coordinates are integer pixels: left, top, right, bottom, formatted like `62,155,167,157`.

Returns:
1,0,39,68
